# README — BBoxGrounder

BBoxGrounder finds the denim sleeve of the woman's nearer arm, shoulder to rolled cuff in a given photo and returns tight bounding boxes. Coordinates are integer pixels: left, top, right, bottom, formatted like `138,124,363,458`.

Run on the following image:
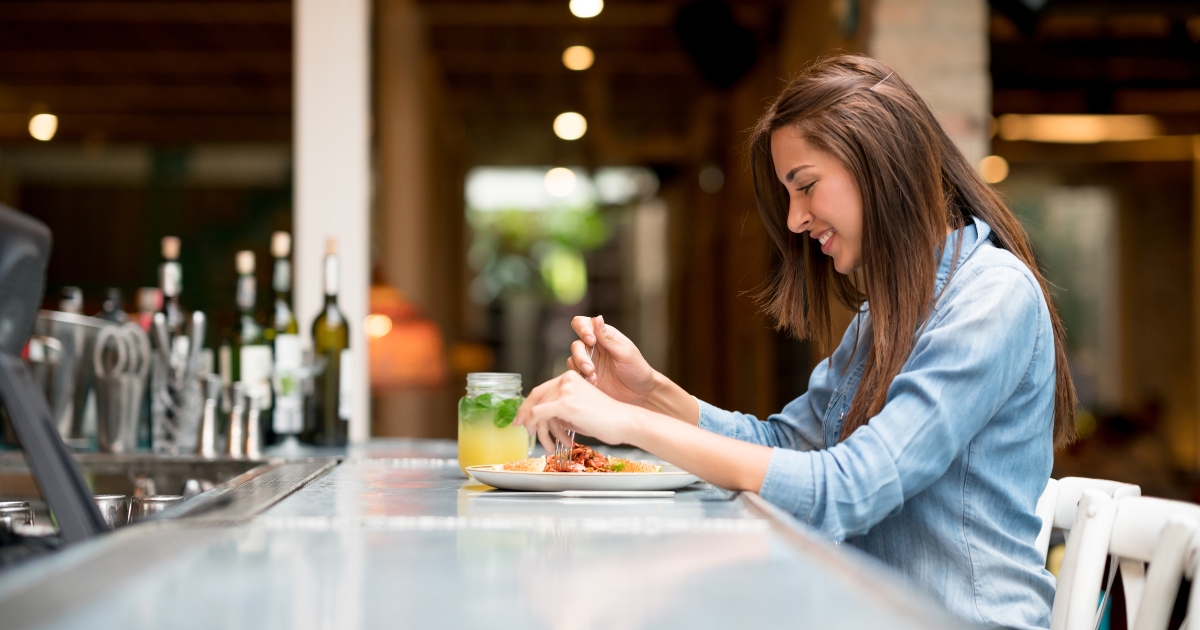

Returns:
760,266,1054,540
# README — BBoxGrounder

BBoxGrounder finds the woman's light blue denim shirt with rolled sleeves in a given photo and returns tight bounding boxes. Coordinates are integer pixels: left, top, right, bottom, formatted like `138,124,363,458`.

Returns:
700,218,1055,629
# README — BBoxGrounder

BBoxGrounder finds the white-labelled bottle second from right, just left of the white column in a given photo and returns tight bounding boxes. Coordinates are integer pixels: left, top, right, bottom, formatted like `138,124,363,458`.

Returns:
266,232,304,444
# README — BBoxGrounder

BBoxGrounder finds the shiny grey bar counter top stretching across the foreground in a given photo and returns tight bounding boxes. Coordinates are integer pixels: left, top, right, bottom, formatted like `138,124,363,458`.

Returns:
0,440,966,630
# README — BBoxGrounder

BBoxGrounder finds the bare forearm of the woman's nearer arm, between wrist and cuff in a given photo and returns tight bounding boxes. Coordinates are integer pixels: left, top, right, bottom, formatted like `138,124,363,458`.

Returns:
625,408,772,492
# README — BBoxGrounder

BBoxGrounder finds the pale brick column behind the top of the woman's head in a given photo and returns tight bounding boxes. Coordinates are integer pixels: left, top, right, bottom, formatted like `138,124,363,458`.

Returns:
869,0,991,166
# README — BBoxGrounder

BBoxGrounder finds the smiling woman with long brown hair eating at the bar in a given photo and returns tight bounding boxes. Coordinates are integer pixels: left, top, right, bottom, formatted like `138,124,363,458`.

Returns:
516,56,1075,628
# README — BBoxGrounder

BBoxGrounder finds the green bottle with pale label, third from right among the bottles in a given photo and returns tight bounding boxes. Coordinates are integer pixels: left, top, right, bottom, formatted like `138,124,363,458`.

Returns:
229,251,271,436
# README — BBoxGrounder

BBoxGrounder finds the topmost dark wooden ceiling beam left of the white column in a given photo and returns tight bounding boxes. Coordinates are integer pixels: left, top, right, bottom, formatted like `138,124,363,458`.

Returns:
2,0,292,24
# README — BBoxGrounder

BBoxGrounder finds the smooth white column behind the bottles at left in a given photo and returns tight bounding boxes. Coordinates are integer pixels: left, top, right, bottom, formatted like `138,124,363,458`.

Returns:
293,0,371,442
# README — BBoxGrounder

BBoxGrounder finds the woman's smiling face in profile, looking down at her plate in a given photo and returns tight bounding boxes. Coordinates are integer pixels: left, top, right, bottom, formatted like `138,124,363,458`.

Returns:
770,126,863,275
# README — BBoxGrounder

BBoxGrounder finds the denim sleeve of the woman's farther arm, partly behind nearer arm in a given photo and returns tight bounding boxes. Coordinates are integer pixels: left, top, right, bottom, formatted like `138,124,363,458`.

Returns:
697,317,859,451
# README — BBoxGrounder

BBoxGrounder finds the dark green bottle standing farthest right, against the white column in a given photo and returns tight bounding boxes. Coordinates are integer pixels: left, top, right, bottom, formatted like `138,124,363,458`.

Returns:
301,239,353,446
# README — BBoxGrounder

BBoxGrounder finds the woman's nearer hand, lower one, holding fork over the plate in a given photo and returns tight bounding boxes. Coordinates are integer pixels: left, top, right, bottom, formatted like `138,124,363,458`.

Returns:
512,372,641,452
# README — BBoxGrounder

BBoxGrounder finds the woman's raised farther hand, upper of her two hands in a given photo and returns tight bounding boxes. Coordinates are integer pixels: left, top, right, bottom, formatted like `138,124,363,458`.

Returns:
566,316,658,404
